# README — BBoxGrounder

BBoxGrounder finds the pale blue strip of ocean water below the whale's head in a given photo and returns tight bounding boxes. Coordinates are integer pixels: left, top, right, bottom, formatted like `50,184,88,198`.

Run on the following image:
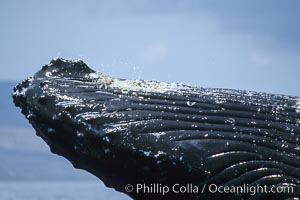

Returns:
0,181,130,200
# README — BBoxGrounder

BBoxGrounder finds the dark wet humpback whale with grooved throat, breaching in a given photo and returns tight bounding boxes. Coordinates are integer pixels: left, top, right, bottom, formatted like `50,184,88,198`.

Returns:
13,58,300,200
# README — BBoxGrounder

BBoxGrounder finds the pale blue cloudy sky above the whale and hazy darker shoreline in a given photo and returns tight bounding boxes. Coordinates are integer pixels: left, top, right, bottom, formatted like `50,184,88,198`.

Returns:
0,0,300,96
